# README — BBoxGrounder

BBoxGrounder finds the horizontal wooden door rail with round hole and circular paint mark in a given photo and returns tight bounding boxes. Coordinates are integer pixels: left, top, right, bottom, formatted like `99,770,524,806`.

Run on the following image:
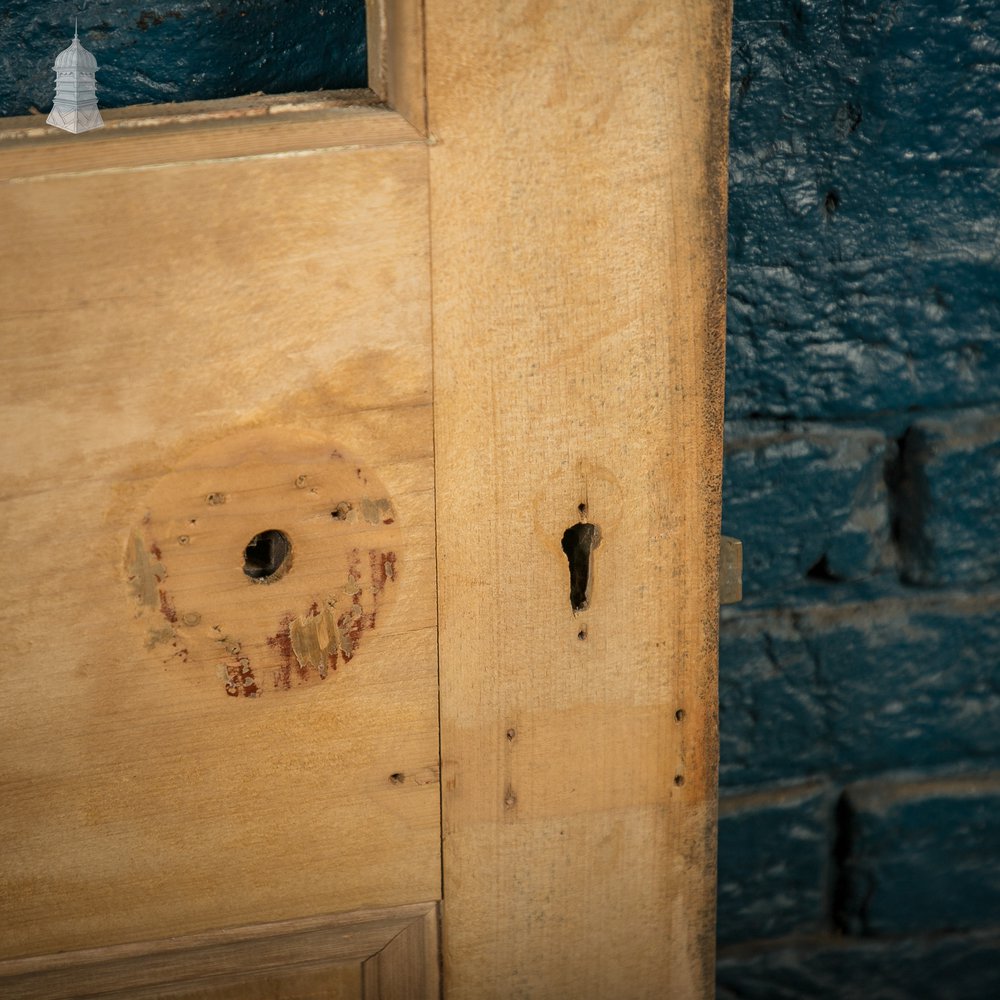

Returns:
0,108,440,957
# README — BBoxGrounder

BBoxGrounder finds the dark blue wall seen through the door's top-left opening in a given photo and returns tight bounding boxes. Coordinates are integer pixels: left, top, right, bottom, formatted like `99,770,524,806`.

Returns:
0,0,368,116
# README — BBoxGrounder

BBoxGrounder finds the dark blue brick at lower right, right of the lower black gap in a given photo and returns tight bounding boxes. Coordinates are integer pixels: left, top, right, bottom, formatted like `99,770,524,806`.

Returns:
838,773,1000,935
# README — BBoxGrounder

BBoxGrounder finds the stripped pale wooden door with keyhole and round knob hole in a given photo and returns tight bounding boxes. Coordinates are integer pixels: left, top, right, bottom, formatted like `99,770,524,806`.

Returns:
0,0,728,1000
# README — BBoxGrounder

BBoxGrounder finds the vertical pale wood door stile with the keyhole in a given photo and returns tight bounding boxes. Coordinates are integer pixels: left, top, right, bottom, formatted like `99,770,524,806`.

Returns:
426,0,728,1000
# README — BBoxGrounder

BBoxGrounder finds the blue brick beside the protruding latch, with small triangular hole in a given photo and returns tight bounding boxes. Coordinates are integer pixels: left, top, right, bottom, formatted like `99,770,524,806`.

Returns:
723,427,889,603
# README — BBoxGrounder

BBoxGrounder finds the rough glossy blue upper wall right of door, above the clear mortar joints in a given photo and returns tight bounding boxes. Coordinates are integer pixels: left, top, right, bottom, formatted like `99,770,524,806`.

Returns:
727,0,1000,418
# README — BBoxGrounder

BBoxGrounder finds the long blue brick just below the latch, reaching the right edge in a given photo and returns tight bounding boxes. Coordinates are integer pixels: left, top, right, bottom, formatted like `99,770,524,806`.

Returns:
719,593,1000,788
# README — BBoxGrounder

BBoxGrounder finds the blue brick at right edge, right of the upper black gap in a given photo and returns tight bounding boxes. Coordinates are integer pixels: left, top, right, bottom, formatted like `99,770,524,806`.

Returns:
896,412,1000,586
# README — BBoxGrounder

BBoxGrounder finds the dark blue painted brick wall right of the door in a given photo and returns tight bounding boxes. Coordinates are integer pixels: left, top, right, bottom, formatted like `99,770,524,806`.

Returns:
718,0,1000,1000
